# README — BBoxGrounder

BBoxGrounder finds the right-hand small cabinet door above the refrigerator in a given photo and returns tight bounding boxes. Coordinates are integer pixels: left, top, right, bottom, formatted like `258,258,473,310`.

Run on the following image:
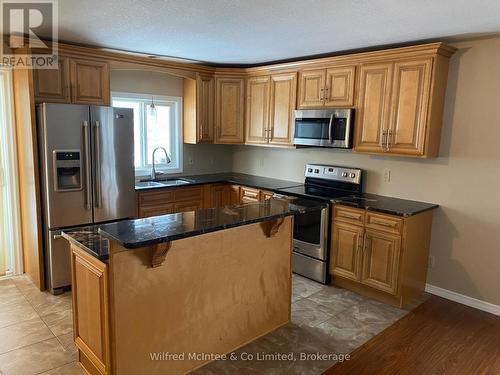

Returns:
71,59,110,105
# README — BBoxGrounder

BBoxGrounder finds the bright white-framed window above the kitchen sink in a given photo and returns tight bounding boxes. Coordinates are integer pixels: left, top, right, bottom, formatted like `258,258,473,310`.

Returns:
112,92,182,176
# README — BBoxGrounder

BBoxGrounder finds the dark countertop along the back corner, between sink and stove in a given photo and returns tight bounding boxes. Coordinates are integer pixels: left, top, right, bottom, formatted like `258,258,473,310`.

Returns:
135,172,301,191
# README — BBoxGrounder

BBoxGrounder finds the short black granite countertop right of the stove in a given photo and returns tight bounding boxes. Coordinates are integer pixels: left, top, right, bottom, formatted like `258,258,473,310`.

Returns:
333,193,439,217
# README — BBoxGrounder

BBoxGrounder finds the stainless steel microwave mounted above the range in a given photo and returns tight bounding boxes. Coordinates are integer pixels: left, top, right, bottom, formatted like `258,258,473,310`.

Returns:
293,108,354,148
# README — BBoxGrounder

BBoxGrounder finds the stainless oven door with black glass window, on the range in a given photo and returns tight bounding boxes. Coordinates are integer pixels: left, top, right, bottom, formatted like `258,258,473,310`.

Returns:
293,204,328,261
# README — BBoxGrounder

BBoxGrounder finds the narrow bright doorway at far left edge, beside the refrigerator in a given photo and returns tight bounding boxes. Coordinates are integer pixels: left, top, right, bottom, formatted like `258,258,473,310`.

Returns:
0,68,22,277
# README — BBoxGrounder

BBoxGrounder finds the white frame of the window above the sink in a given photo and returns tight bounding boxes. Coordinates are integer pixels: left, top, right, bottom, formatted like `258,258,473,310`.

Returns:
111,91,184,178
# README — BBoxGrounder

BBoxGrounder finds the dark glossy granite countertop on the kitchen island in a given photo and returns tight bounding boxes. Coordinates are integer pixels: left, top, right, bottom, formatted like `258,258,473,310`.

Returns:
63,199,326,260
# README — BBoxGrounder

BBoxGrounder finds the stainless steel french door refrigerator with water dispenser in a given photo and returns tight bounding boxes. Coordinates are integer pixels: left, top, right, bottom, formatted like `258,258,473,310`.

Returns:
38,103,135,294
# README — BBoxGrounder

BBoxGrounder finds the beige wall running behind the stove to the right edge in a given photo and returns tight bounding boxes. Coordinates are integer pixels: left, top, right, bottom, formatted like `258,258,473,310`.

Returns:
233,37,500,305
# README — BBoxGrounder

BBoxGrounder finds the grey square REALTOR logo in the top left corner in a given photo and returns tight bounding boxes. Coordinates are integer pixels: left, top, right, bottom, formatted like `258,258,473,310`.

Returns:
0,0,58,69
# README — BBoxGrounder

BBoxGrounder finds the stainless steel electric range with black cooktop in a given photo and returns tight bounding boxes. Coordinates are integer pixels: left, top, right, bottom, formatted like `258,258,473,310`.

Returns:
279,164,363,284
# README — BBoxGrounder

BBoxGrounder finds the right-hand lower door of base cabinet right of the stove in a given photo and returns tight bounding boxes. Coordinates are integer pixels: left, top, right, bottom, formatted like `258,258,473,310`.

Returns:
361,229,401,294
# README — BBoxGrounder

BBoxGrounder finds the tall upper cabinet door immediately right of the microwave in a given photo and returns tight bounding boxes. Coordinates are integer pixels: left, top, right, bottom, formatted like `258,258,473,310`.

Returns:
354,63,393,153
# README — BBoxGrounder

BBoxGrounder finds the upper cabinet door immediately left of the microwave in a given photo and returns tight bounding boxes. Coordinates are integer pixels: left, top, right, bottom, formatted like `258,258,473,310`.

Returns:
269,73,297,145
